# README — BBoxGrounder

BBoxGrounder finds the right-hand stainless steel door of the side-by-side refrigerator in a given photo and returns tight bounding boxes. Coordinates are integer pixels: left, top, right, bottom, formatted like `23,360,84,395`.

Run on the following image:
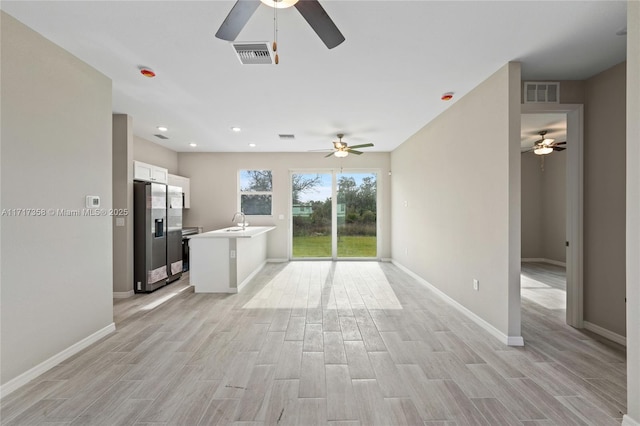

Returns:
167,185,182,283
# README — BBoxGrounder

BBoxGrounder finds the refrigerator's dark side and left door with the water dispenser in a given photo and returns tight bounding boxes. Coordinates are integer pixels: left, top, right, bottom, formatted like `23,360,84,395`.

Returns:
133,182,169,293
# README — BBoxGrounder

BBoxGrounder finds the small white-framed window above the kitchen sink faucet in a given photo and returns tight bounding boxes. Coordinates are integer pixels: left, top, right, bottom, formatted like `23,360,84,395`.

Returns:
240,170,273,216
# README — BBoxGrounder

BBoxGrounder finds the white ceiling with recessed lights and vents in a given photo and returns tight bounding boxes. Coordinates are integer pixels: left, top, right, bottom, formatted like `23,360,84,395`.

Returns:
0,0,626,152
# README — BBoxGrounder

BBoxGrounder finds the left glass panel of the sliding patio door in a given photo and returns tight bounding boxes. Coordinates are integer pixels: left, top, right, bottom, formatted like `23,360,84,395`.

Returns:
291,173,333,259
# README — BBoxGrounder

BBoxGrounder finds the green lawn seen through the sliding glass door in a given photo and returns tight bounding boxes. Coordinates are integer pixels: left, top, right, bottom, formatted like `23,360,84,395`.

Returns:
293,235,377,257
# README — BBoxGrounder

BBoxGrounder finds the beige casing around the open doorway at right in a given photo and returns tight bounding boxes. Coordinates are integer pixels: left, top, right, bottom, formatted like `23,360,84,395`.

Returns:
520,103,584,328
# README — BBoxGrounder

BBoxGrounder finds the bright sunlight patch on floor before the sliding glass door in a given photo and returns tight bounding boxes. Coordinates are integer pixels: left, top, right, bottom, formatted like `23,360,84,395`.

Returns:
243,261,402,310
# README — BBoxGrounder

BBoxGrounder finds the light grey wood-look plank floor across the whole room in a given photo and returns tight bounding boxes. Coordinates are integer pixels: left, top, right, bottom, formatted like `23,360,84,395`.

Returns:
1,262,626,426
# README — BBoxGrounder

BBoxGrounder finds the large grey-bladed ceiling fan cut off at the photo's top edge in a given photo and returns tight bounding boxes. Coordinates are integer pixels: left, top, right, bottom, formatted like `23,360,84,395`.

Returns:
216,0,344,49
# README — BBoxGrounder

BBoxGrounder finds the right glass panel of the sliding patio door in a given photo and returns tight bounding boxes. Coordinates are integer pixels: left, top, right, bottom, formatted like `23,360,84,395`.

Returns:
336,173,378,257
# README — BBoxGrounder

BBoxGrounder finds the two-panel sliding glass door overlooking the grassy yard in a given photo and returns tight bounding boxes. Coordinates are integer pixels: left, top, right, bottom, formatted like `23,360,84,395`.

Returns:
291,171,378,259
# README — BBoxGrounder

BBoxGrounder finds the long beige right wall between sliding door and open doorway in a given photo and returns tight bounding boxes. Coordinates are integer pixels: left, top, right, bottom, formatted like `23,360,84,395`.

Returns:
391,63,521,338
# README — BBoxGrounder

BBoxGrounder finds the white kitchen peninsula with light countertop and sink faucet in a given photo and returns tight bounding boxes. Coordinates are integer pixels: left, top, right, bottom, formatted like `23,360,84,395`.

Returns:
189,226,275,293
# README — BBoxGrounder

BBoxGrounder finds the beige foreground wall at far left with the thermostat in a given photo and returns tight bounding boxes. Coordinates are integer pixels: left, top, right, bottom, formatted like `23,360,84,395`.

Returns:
1,12,113,392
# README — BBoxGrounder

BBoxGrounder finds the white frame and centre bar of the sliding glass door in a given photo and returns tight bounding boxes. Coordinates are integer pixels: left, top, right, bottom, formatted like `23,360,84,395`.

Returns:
287,167,382,261
